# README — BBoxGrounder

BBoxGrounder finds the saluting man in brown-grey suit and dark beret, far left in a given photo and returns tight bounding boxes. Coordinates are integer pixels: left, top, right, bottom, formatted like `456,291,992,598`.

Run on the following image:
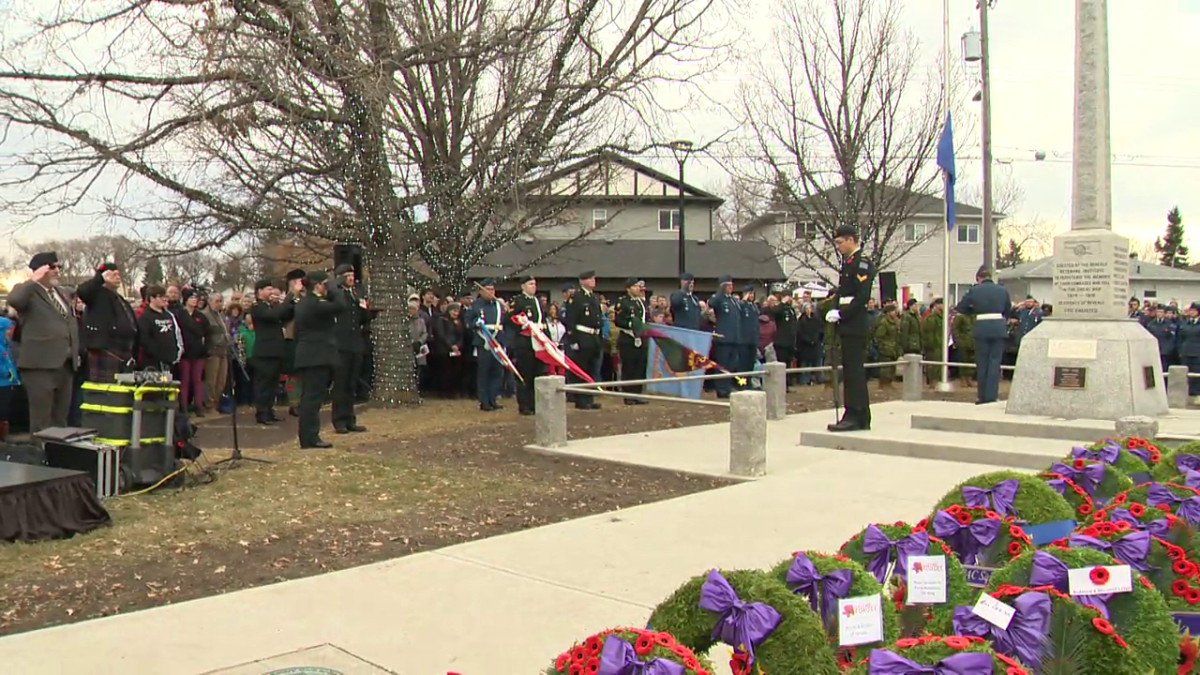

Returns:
8,251,79,434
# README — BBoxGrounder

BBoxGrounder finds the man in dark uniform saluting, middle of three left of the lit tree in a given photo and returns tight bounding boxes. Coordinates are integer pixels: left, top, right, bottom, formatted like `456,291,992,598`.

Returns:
294,271,346,449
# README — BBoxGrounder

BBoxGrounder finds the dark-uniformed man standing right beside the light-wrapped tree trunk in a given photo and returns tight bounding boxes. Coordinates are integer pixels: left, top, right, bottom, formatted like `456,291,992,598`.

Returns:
332,264,371,434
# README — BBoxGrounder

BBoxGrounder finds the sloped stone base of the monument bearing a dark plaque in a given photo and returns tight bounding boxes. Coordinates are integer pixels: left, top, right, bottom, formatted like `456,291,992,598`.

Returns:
1004,318,1168,420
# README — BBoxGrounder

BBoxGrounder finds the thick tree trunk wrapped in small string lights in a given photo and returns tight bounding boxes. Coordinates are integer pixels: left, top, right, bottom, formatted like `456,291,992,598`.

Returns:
364,245,421,406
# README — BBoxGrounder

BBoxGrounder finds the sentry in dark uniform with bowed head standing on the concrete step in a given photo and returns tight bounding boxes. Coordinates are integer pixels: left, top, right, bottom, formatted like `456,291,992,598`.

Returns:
826,225,875,431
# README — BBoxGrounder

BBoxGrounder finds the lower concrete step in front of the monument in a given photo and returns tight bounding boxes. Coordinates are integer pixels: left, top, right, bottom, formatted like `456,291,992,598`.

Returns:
800,426,1073,470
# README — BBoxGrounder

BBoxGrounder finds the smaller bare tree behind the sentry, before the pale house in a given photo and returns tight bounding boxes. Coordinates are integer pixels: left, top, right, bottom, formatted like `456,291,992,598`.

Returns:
742,0,965,279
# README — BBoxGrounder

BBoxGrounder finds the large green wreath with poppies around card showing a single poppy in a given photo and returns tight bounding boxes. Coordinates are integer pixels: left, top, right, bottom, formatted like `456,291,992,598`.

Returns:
974,545,1180,675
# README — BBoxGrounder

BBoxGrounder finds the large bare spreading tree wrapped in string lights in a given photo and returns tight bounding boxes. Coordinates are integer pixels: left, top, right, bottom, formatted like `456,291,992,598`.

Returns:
0,0,715,402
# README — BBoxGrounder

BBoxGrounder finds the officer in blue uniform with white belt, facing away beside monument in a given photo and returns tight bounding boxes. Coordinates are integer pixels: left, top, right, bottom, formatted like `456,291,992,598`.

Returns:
954,267,1015,405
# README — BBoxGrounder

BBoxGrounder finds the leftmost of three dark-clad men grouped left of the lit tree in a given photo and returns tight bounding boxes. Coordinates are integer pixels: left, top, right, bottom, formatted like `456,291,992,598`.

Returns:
250,279,295,424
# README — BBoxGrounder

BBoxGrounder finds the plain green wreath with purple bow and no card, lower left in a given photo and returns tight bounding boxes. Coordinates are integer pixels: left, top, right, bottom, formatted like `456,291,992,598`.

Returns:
650,569,839,675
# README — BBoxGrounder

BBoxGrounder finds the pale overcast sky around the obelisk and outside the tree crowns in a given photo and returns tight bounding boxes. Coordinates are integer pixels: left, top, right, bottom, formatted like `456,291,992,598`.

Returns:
0,0,1200,260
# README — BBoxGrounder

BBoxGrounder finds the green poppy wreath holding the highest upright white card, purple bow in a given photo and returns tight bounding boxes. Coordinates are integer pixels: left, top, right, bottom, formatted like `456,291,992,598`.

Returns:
838,521,976,638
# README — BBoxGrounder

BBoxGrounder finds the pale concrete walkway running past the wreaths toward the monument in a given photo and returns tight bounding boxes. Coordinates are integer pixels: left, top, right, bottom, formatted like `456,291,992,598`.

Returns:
0,444,994,675
